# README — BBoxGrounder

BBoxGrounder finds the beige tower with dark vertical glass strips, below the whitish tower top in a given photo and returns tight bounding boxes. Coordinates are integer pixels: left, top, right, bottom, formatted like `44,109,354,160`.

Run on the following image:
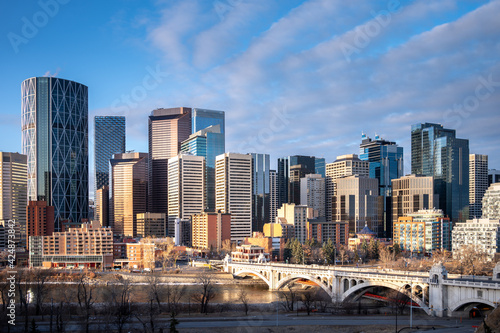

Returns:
332,175,383,235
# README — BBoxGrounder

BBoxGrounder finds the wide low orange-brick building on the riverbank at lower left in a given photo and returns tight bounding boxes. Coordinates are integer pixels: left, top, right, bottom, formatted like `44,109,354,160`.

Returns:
29,223,113,268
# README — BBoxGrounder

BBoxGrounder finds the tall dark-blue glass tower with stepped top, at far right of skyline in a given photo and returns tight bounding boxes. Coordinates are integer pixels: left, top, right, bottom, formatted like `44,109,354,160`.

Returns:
411,123,469,222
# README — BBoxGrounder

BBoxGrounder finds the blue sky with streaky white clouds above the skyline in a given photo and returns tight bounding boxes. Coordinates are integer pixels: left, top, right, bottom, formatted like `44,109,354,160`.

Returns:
0,0,500,189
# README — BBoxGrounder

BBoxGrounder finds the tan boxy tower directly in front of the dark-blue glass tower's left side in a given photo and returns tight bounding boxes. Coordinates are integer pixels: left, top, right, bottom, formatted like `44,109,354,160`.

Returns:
387,175,435,226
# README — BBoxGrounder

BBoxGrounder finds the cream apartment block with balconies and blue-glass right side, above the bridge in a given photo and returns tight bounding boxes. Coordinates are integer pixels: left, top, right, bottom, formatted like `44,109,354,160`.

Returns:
393,209,452,255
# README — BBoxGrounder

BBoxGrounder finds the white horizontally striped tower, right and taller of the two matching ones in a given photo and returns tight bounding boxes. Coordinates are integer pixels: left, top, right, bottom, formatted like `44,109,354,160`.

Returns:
215,153,252,242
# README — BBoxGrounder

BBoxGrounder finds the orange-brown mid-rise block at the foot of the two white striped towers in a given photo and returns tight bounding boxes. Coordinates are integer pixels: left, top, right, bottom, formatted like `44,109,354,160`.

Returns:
191,212,231,251
